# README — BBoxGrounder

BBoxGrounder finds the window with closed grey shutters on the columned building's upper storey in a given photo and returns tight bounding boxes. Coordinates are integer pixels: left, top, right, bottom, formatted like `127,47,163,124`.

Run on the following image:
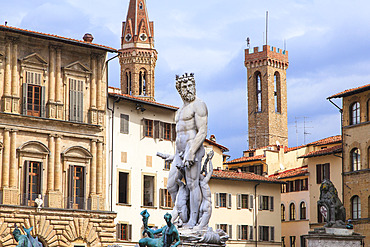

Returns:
69,79,83,122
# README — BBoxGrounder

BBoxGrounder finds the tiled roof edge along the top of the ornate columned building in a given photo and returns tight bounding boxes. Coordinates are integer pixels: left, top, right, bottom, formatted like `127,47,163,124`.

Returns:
0,25,117,52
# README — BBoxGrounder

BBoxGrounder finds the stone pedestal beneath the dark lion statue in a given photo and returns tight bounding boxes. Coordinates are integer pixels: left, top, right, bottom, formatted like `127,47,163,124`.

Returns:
305,228,365,247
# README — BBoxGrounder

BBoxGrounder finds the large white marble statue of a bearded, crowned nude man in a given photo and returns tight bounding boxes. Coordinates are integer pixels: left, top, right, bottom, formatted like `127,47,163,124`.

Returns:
167,74,208,228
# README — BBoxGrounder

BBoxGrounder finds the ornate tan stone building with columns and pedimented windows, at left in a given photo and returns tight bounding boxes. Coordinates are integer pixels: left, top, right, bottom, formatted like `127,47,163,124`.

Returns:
0,26,117,246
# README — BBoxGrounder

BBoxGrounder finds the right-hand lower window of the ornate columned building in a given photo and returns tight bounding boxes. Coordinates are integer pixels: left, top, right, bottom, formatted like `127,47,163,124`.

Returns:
68,165,86,209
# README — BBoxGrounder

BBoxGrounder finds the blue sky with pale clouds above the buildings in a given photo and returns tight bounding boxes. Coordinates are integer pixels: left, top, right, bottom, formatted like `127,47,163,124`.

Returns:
0,0,370,158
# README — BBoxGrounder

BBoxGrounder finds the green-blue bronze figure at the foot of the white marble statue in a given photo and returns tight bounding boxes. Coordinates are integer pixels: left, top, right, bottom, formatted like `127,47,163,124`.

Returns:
139,210,180,247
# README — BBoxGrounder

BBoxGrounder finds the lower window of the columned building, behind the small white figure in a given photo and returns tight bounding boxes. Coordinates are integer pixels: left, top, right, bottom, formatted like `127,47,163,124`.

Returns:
24,161,42,206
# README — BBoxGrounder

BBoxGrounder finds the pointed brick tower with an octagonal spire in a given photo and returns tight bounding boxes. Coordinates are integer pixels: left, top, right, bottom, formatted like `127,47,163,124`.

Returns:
119,0,157,101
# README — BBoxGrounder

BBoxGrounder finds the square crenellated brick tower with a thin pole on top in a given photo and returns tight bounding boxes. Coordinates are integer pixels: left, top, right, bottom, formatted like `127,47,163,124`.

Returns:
245,45,289,148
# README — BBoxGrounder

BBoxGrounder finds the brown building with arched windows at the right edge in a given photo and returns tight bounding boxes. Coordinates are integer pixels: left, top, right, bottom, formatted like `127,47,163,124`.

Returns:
328,84,370,246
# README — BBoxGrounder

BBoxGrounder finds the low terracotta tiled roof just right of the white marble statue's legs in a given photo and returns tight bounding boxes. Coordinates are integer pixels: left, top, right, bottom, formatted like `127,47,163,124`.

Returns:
212,170,281,183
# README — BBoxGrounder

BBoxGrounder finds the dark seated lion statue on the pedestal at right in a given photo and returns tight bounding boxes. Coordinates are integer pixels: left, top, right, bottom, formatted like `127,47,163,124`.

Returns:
317,179,346,228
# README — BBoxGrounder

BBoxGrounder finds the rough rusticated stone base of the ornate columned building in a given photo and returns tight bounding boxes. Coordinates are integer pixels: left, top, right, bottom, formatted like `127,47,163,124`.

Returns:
0,206,116,247
